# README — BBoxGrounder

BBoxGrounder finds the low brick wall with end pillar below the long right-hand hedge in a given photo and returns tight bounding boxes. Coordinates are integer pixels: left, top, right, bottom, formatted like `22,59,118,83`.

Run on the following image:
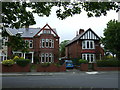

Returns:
93,63,120,71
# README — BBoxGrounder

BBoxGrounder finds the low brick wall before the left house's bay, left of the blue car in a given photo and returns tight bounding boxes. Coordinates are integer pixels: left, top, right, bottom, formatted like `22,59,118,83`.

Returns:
37,64,66,72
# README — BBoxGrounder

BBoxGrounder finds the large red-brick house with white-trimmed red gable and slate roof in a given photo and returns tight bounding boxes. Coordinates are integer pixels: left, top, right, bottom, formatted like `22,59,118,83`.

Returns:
6,24,59,63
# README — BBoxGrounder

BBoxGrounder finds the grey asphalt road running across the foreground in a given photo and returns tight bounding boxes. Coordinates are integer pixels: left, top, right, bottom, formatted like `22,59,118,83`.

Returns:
2,72,120,88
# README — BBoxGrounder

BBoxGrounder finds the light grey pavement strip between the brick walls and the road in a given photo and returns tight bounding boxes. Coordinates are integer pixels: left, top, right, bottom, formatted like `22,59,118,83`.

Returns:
0,69,120,76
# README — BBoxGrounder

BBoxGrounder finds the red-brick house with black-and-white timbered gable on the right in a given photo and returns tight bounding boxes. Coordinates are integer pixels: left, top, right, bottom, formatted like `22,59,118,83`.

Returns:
66,28,104,63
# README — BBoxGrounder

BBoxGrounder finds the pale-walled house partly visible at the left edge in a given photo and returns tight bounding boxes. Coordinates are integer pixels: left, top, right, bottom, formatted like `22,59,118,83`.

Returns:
0,23,8,61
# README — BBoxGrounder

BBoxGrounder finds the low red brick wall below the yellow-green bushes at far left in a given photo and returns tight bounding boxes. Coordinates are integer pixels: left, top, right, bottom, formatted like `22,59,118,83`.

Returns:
2,64,30,72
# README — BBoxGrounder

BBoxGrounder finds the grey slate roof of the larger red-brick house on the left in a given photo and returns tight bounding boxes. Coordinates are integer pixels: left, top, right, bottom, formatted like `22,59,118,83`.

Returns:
7,28,57,38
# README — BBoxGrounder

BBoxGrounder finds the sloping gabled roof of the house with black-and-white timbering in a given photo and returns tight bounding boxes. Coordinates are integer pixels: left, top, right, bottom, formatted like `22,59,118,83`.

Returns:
66,28,100,46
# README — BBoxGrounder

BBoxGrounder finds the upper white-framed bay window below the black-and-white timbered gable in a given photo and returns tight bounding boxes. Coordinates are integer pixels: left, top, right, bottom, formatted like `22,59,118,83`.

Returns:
82,40,95,49
